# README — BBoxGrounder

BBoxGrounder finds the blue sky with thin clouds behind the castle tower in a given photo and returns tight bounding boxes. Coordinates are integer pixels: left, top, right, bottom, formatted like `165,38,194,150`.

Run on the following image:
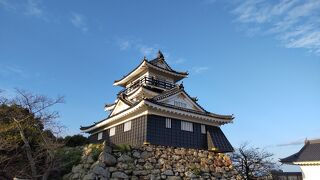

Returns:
0,0,320,172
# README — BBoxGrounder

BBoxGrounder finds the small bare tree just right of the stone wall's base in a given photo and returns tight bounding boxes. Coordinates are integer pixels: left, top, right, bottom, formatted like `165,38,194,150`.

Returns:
231,143,277,180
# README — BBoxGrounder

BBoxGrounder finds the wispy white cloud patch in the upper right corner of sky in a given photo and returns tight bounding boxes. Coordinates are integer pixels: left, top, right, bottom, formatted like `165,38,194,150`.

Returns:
231,0,320,54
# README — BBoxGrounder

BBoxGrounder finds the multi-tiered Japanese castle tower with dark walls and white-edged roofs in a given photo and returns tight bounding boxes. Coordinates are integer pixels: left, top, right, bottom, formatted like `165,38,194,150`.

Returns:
80,51,234,152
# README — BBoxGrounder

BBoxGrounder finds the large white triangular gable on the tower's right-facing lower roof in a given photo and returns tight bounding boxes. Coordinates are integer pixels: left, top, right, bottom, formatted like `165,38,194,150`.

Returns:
159,91,204,112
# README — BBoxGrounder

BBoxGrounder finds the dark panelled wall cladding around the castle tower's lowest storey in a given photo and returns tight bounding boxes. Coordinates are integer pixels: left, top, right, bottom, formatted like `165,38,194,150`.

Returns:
89,115,233,152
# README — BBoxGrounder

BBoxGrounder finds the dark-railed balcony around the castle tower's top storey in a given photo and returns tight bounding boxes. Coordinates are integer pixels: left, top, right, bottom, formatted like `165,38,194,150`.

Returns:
119,77,176,94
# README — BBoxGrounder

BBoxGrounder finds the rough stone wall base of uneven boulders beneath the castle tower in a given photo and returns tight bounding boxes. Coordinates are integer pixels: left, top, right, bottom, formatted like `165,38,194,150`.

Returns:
64,145,240,180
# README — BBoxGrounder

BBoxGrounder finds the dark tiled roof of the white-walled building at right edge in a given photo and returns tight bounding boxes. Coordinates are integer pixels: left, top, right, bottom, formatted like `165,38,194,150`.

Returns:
280,139,320,164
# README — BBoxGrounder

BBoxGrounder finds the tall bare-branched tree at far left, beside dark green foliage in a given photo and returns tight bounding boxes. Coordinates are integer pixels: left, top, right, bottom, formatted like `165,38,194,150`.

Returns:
0,89,64,180
